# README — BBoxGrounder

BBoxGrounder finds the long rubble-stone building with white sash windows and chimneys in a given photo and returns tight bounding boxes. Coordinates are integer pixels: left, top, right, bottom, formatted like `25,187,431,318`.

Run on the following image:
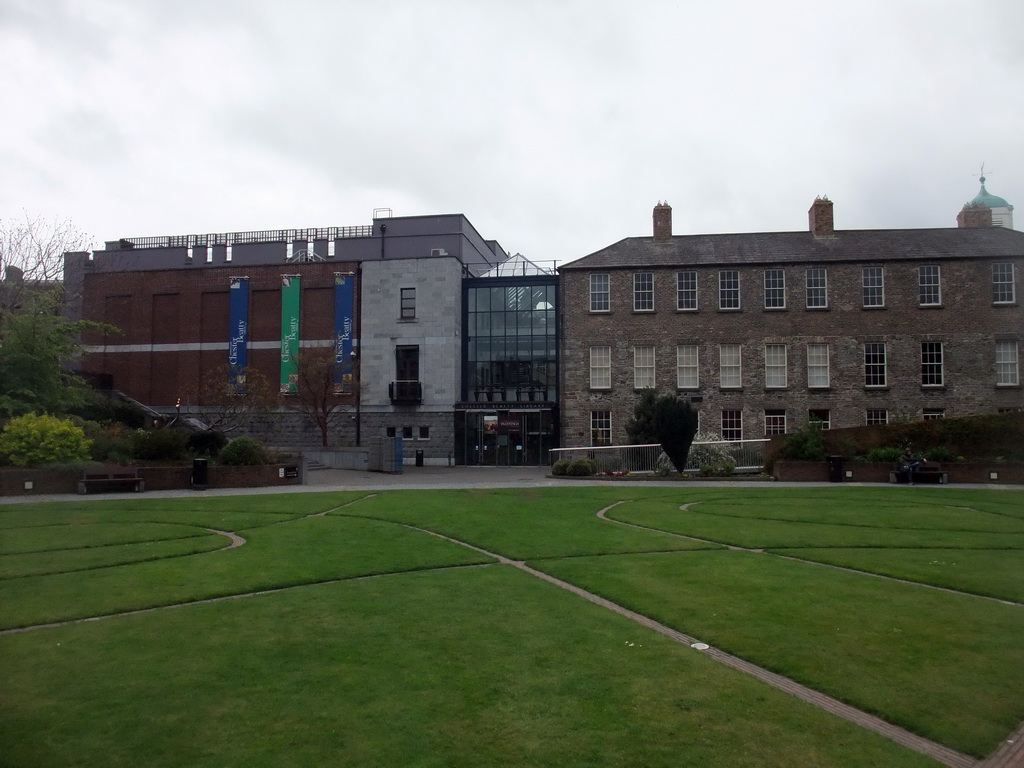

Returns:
559,193,1024,446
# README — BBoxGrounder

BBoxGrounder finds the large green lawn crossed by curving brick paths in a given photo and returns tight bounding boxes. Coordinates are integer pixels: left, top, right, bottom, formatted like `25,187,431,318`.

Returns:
0,485,1024,768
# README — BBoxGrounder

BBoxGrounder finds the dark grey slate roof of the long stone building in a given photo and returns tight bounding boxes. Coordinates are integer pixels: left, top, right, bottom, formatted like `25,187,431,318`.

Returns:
559,226,1024,270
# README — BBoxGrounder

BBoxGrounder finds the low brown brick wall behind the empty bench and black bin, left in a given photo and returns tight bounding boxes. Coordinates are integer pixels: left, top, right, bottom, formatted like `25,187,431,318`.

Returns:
0,464,302,497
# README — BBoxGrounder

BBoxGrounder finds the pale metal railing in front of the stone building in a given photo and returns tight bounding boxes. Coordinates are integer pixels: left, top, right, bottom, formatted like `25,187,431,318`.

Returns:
551,439,769,474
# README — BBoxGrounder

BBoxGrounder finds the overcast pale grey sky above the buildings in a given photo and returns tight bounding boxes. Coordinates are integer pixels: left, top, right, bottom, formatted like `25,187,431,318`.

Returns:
0,0,1024,261
